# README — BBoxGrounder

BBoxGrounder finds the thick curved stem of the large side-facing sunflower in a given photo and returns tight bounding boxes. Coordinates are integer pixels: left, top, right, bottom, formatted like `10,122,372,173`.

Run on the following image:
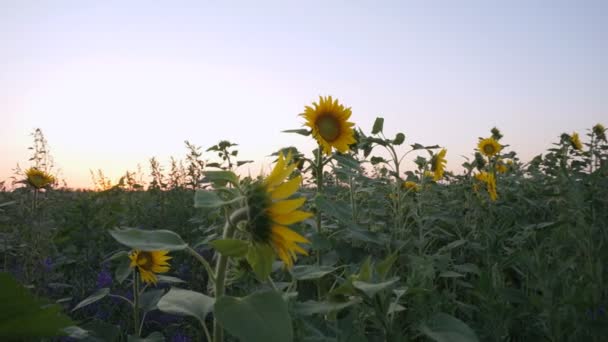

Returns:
213,207,249,342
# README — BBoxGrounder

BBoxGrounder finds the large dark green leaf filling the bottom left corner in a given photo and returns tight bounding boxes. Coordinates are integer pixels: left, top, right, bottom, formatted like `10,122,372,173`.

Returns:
0,273,74,341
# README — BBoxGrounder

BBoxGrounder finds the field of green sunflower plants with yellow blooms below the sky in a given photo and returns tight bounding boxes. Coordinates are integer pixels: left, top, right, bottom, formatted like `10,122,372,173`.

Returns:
0,97,608,342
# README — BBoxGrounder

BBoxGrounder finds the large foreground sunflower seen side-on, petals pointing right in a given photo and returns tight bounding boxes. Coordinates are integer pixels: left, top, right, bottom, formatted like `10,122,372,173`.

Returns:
248,153,312,268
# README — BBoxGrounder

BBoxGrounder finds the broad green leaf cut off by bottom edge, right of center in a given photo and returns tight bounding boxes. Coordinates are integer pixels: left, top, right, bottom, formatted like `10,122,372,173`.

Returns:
420,312,479,342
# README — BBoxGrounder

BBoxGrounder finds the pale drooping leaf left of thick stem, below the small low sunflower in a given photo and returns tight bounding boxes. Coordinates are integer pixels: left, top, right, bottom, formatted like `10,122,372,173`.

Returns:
157,287,215,324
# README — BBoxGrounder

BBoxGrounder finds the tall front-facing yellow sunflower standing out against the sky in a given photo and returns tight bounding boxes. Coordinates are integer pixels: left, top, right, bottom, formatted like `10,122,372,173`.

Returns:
300,96,356,155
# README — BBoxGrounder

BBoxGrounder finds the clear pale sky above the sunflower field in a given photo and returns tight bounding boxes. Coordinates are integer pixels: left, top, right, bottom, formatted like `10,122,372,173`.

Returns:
0,0,608,187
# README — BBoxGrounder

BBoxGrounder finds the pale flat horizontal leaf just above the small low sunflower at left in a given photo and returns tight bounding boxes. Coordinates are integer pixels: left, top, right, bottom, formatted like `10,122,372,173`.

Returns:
110,228,188,251
